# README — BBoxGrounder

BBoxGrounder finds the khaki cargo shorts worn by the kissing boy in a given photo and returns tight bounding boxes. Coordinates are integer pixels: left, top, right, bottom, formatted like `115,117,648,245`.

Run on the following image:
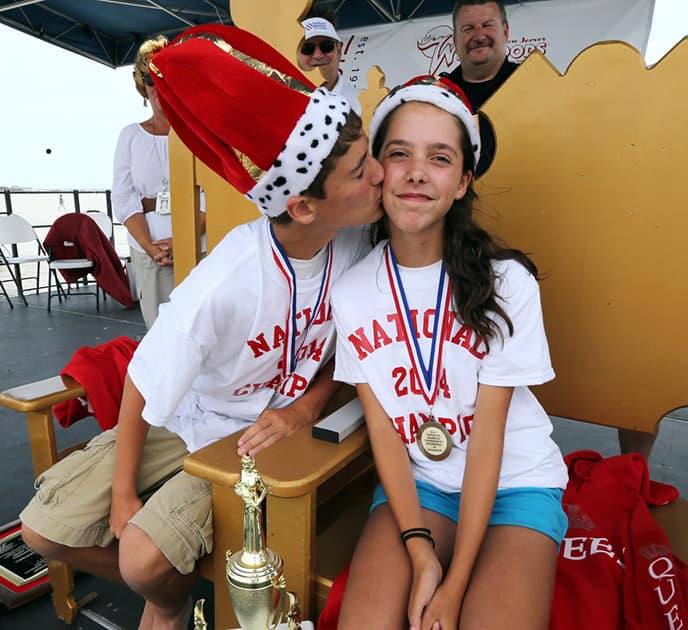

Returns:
19,427,213,574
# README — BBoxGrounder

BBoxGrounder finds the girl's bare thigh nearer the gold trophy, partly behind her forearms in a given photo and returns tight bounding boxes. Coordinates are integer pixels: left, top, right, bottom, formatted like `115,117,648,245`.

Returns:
337,503,456,630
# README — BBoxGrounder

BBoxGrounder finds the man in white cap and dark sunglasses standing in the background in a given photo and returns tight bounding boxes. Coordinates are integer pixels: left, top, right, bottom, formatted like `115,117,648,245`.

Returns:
297,12,361,115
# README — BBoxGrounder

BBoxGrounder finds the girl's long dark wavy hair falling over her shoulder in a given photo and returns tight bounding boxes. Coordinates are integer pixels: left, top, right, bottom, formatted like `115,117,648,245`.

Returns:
371,104,538,351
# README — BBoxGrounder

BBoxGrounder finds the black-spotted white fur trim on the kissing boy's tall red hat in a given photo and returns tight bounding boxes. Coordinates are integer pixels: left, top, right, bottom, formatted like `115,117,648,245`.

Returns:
246,88,351,217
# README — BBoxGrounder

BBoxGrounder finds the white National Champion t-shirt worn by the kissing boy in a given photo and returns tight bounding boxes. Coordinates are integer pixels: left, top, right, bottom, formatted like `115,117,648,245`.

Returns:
123,218,370,451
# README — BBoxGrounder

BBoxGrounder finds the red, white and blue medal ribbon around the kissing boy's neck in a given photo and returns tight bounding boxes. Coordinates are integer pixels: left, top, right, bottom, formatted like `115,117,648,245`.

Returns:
268,223,333,378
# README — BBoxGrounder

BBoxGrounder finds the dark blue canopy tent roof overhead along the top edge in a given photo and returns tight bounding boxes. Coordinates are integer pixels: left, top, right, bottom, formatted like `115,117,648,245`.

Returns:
0,0,532,68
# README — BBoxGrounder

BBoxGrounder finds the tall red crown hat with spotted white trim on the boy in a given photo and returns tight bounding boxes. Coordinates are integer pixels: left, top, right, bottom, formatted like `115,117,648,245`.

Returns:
149,24,351,216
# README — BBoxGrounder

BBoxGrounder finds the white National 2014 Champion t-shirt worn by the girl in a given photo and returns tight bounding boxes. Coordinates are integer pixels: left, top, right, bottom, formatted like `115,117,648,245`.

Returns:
332,243,567,492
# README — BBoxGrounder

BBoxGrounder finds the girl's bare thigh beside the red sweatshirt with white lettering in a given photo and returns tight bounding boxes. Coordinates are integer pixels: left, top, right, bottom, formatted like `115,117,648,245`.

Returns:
460,526,557,630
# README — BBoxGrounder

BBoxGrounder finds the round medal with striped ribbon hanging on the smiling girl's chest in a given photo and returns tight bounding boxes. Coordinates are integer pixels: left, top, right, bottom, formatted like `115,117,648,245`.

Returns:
385,244,452,461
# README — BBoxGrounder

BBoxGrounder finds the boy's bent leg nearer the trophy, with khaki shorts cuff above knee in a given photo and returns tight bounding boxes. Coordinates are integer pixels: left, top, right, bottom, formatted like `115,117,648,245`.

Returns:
119,472,213,630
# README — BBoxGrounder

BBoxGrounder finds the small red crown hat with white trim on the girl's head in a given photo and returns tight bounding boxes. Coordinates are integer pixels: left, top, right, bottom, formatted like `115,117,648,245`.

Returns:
370,75,480,170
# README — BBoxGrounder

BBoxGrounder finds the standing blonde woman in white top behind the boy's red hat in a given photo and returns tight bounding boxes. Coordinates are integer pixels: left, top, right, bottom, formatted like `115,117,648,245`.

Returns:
112,35,204,328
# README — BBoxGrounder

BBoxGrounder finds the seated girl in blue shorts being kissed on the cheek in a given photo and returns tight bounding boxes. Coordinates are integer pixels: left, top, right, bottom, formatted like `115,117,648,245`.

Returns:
332,77,567,630
